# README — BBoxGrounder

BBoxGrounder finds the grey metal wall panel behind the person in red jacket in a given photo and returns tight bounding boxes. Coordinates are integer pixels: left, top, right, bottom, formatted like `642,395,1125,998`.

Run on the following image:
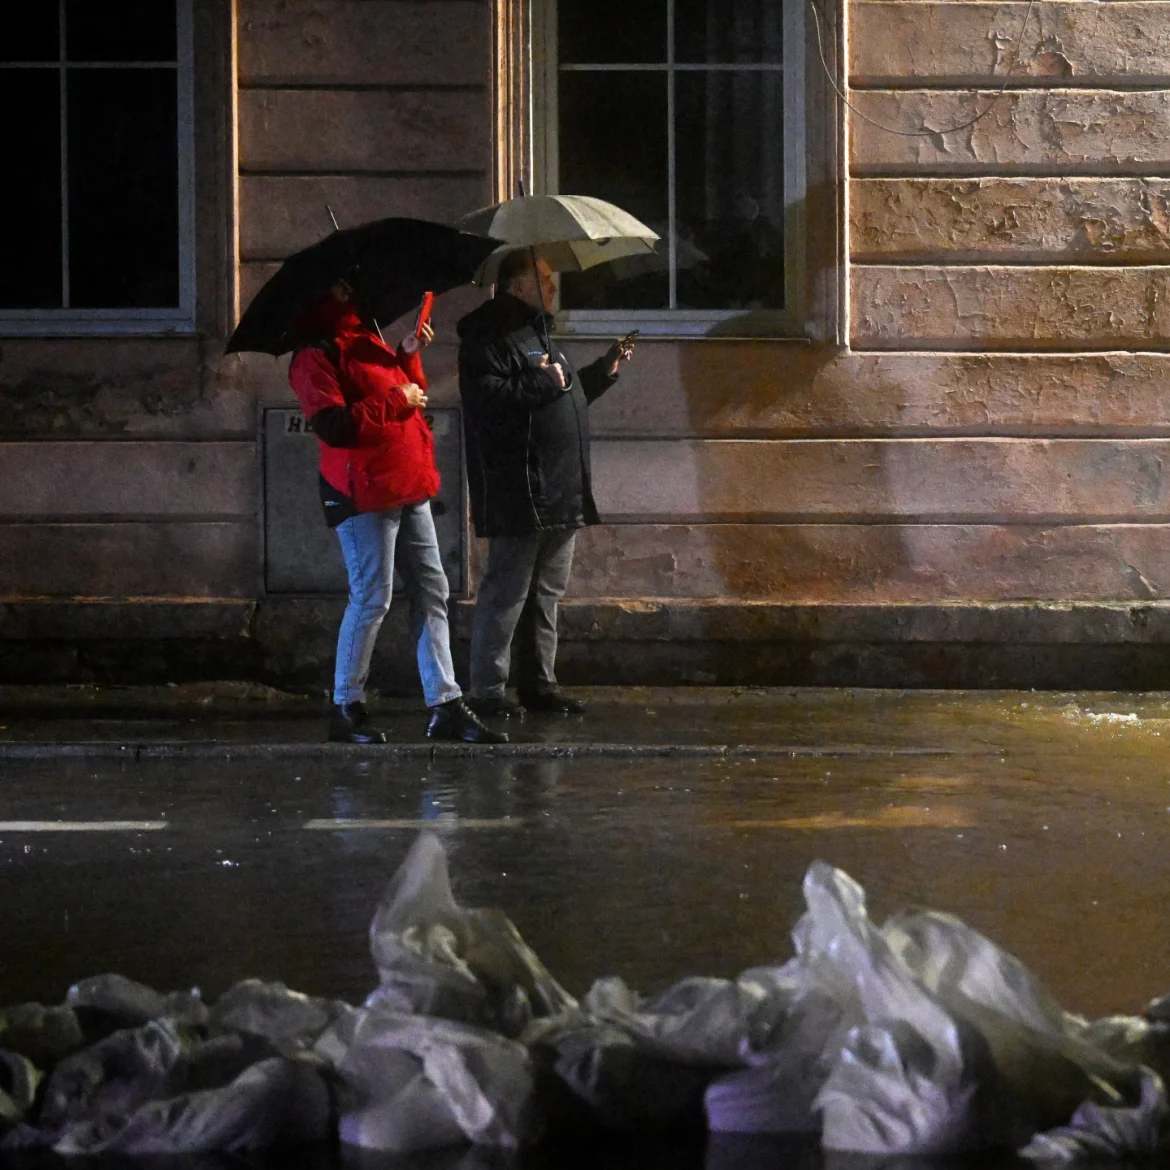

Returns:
264,407,467,597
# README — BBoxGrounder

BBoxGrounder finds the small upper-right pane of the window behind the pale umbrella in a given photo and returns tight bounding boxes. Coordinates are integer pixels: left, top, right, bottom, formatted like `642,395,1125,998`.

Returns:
674,0,787,64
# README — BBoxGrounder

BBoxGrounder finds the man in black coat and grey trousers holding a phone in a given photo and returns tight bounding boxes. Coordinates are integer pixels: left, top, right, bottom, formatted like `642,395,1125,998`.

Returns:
459,250,633,716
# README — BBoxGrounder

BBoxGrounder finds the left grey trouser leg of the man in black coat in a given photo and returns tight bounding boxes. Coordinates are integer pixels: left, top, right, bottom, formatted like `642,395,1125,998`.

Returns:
470,532,541,698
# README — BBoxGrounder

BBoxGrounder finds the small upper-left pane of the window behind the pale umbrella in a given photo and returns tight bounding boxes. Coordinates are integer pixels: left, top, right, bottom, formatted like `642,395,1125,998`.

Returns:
557,0,666,64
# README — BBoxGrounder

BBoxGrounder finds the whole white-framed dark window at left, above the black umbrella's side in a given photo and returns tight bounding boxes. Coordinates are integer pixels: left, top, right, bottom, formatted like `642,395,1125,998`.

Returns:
0,0,194,333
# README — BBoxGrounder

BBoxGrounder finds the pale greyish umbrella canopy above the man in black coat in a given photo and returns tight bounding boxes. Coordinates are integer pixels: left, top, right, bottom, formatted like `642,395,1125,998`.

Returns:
457,195,658,284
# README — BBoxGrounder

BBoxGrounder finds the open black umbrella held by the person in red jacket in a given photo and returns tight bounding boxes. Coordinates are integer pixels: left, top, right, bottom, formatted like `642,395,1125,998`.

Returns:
226,219,500,355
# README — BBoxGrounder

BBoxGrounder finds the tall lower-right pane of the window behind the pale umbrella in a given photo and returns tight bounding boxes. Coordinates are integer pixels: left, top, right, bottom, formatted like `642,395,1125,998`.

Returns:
675,73,784,309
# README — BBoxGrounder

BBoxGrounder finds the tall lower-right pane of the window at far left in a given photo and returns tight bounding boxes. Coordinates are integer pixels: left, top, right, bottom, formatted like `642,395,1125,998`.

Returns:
68,69,179,309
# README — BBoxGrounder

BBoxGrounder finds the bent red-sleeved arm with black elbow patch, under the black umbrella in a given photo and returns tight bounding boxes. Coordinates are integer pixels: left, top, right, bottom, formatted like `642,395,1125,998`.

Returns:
289,349,426,447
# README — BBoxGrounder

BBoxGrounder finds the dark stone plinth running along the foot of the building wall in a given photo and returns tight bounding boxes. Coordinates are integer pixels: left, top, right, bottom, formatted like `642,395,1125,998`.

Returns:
0,598,1170,696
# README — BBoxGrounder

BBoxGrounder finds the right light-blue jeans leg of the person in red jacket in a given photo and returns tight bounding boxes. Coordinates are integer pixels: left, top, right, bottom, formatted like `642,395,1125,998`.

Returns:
398,501,462,707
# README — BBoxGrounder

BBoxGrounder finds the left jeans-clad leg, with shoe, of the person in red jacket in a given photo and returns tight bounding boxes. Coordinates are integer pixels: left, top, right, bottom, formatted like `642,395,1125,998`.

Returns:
331,509,400,742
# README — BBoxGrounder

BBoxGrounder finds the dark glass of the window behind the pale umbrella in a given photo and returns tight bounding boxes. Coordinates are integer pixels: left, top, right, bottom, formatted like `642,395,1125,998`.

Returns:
558,0,784,310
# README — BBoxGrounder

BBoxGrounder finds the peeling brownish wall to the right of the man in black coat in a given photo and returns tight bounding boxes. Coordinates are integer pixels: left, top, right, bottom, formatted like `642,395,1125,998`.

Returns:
573,0,1170,640
